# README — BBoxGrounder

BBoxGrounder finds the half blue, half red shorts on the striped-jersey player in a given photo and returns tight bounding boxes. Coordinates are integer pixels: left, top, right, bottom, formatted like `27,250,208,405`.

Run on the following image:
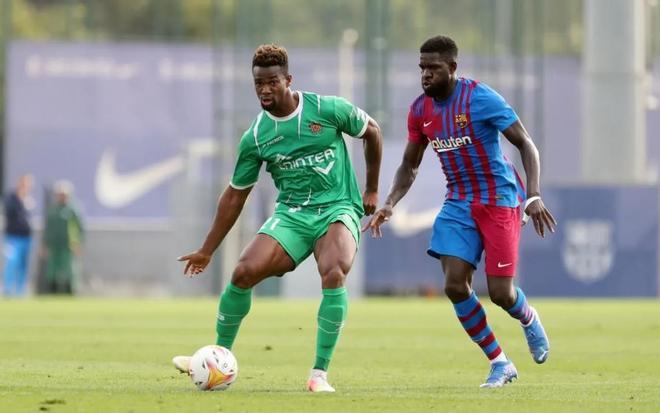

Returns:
426,199,521,277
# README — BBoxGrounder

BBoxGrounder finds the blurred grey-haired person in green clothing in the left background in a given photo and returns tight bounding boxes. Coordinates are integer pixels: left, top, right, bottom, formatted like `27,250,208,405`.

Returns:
42,181,83,294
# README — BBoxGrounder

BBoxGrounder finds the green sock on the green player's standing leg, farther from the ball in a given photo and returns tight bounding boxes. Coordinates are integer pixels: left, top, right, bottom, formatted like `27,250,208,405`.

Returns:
314,287,348,371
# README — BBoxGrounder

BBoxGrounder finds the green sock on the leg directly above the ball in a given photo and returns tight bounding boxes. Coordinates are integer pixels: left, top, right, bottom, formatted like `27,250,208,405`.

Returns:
215,283,252,349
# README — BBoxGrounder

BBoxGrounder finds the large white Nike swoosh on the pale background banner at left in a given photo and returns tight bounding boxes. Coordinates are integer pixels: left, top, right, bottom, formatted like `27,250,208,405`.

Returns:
94,150,184,208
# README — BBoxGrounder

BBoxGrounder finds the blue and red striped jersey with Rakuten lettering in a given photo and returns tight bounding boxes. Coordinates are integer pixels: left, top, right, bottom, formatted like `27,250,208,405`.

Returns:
408,78,525,207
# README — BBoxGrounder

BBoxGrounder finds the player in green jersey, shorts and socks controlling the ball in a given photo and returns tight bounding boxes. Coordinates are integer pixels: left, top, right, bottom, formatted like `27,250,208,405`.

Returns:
173,45,382,392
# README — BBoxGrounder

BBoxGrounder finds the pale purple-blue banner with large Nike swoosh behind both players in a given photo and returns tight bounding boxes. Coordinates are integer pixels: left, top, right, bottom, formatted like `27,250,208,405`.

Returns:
5,41,660,219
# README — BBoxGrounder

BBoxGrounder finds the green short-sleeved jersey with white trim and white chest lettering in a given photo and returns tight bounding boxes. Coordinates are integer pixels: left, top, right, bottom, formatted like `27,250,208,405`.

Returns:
231,92,369,212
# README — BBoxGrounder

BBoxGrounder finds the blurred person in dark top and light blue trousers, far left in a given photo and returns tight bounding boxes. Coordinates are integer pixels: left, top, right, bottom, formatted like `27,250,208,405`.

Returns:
3,174,34,296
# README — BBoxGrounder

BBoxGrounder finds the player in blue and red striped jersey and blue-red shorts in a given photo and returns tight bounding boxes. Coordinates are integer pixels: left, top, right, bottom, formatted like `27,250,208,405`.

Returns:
363,36,557,387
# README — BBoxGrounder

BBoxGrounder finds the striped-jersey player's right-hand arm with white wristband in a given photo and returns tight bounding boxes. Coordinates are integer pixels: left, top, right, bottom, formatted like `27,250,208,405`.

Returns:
502,121,557,237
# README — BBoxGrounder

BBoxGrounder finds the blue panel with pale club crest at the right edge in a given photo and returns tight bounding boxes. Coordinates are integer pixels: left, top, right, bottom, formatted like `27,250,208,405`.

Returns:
519,186,658,297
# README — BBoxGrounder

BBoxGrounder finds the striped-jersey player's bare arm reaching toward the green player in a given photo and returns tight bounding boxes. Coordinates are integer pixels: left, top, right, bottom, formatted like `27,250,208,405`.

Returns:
362,141,426,238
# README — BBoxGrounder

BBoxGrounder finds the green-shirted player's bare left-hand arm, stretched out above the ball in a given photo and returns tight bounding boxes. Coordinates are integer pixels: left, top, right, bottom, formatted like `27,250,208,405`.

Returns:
177,186,252,277
